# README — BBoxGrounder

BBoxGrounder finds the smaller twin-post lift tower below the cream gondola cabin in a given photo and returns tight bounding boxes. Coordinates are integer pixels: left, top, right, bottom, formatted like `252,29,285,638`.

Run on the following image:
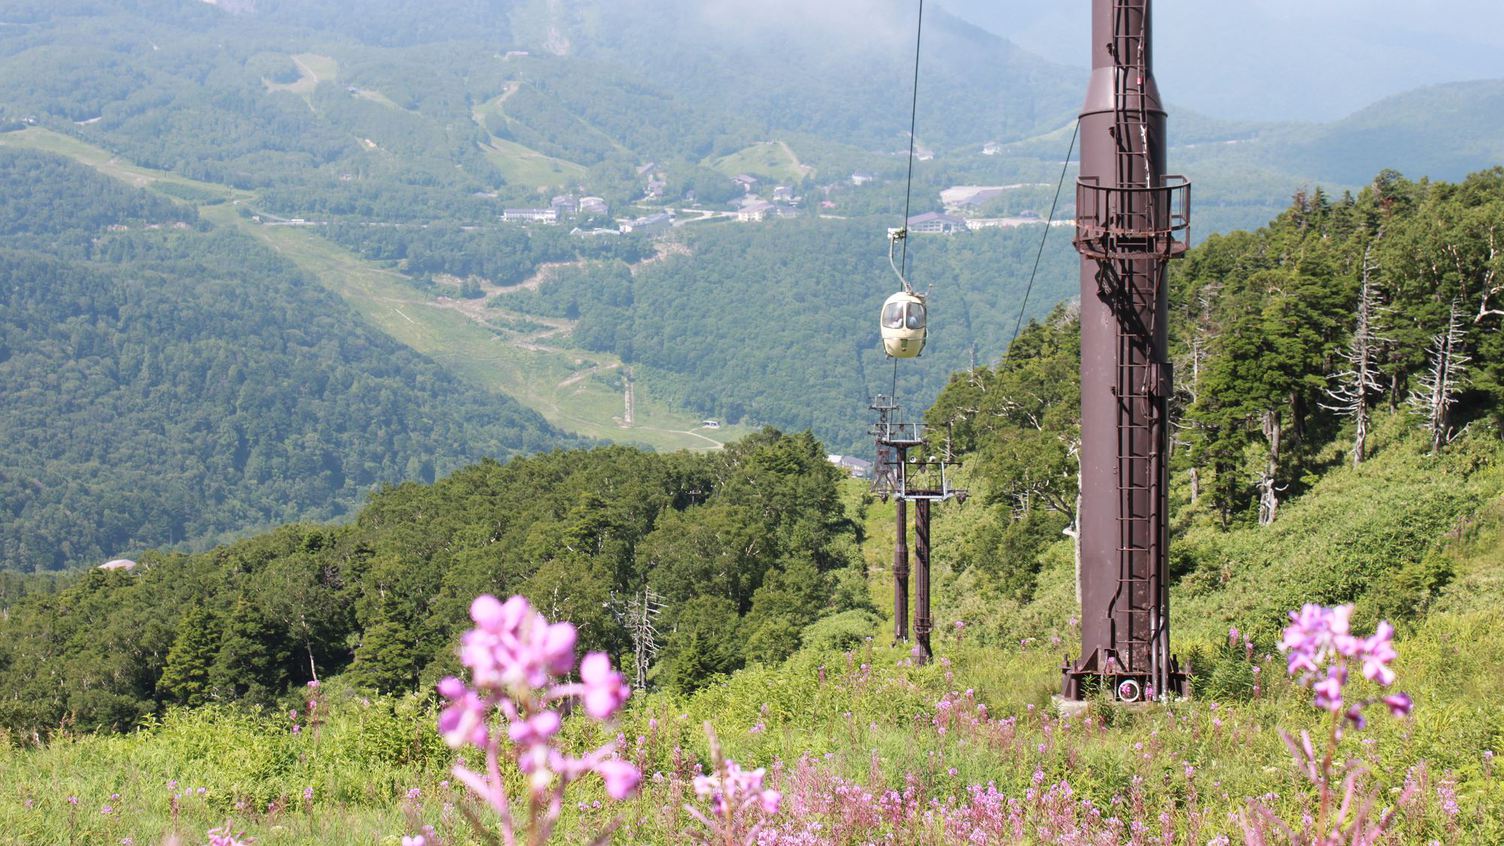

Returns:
871,396,966,662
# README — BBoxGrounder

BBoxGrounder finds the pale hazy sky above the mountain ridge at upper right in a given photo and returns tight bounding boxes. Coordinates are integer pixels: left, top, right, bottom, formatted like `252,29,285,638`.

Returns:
940,0,1504,120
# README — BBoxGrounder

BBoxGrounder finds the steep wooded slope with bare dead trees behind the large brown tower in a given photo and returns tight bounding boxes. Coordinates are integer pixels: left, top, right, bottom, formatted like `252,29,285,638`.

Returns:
928,169,1504,641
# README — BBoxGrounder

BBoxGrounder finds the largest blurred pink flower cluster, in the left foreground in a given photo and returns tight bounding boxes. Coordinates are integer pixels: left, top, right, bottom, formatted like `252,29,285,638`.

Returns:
438,595,642,843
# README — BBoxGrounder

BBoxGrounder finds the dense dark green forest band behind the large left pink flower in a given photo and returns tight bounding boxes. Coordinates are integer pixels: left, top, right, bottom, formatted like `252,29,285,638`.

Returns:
0,431,871,732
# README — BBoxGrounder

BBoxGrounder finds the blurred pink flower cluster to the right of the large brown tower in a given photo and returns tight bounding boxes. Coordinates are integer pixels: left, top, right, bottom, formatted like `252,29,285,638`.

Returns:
1280,604,1414,729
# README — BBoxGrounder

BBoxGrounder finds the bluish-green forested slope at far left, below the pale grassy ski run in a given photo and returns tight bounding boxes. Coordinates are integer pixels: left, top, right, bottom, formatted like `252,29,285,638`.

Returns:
0,149,569,569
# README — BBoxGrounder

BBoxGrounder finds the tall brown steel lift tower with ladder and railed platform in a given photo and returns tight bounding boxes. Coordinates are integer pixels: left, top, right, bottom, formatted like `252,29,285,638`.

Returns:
1062,0,1190,700
